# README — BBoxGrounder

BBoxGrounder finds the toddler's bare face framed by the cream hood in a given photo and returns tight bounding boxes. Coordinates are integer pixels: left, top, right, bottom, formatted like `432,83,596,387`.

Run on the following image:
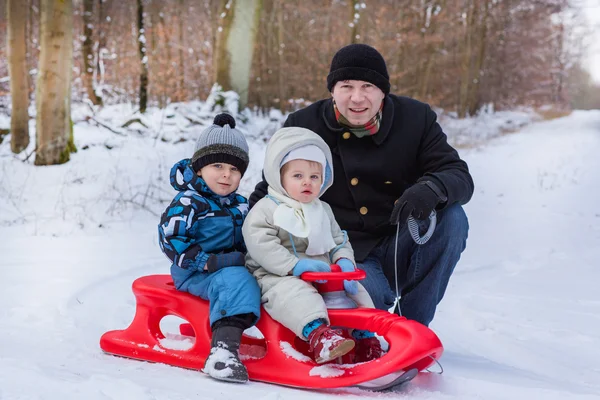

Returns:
281,160,323,203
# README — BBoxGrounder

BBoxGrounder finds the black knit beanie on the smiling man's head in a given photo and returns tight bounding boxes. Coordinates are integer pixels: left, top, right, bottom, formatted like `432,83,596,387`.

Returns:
327,44,390,94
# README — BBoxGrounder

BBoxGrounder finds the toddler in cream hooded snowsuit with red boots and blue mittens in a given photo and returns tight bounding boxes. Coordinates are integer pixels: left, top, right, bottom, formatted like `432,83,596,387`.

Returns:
242,127,382,364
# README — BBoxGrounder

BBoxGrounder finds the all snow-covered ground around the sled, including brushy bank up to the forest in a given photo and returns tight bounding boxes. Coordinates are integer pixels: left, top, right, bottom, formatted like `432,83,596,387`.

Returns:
0,103,600,400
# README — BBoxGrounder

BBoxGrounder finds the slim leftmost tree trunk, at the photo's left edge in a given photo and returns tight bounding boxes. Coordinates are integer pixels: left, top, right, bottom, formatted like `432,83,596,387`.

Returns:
6,0,29,153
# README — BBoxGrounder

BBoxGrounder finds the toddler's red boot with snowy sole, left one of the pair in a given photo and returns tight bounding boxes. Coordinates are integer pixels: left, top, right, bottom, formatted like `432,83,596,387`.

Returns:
308,324,355,364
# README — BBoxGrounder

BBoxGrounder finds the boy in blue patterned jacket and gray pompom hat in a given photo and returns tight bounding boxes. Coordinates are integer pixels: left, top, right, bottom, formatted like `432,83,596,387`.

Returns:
158,114,260,382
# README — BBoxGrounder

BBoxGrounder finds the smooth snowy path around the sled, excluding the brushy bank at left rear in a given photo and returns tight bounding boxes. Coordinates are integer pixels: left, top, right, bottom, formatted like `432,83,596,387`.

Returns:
0,111,600,400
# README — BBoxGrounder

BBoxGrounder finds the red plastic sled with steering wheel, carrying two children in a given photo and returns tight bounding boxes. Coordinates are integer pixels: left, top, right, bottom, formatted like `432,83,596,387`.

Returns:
100,265,443,390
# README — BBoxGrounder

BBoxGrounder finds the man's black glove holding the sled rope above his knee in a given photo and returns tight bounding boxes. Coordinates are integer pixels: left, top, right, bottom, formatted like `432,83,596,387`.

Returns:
390,181,447,225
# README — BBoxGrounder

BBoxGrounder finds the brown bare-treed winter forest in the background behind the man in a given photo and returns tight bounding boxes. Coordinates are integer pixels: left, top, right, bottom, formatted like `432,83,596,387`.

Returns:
0,0,600,165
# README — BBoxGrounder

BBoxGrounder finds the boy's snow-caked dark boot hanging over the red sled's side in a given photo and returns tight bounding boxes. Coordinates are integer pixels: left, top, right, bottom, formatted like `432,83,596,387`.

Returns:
203,325,248,383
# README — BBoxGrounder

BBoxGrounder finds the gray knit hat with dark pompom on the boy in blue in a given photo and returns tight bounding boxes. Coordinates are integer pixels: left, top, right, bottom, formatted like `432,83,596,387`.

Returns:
192,114,250,175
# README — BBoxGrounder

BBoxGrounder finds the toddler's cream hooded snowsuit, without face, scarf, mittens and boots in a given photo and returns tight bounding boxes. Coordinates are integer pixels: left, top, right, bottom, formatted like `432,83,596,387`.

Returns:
242,127,374,338
